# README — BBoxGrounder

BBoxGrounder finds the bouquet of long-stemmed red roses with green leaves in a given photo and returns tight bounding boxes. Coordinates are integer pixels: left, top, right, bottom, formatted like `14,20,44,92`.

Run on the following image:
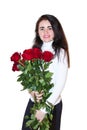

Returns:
10,48,54,130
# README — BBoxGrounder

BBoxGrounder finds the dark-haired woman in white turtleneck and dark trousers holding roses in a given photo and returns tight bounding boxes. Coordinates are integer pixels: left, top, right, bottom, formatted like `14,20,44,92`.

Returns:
22,14,70,130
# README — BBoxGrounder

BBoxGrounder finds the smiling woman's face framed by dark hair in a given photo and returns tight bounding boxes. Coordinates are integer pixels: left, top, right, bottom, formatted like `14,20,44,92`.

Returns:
38,20,54,42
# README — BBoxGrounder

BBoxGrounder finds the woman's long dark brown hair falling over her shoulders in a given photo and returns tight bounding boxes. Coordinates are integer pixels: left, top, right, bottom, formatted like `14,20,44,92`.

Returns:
33,14,70,67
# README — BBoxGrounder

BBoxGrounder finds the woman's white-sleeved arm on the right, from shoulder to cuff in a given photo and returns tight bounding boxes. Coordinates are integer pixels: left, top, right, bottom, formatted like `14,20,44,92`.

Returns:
47,49,68,105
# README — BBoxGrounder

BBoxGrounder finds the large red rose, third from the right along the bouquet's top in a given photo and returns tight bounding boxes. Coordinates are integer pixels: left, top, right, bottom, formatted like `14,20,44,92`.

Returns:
22,49,33,60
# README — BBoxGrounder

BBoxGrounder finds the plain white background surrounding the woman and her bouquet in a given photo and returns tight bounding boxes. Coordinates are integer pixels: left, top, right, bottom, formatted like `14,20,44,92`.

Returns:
0,0,87,130
